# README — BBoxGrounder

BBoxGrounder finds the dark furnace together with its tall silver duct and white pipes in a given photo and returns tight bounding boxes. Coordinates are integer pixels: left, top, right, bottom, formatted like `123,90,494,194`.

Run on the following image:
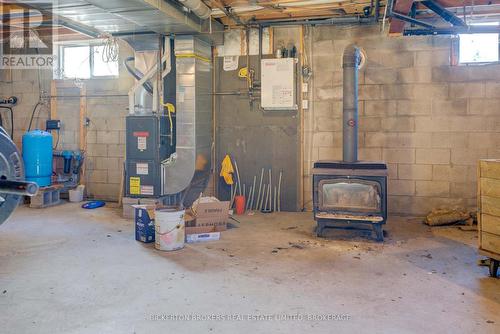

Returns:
125,35,212,206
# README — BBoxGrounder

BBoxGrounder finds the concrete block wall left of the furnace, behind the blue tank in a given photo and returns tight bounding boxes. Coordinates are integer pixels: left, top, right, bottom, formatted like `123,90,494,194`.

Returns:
0,43,134,201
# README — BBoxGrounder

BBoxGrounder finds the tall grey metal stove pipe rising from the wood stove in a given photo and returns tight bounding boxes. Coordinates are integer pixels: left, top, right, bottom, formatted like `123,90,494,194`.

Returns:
342,44,361,162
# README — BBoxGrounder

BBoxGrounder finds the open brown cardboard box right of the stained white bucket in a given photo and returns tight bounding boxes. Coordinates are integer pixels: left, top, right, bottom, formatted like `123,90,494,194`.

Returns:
184,197,229,234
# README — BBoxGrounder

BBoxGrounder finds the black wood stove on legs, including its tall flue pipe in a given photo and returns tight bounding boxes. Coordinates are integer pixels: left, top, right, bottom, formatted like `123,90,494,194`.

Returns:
313,45,387,241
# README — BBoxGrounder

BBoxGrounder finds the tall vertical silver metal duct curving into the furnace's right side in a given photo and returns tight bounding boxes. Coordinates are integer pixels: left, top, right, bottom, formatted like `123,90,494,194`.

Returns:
162,36,212,197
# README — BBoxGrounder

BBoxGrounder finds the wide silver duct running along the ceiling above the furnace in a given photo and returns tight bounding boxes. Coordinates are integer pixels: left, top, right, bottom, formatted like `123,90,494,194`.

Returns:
23,0,223,42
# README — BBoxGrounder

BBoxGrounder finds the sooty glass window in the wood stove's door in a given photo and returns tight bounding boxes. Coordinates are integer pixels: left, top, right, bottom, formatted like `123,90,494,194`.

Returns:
319,179,382,213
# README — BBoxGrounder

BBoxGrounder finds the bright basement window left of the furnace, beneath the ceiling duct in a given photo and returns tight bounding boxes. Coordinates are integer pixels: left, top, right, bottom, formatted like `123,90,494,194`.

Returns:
58,45,118,79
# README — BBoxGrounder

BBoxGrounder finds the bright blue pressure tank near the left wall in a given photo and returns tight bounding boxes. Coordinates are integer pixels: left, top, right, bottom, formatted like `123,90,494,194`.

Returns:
23,130,52,187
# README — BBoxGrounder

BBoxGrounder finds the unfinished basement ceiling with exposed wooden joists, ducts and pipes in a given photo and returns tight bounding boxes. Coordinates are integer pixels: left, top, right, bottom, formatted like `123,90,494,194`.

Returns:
0,0,500,40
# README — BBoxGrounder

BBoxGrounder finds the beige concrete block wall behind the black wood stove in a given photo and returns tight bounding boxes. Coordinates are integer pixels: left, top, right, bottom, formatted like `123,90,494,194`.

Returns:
304,26,500,215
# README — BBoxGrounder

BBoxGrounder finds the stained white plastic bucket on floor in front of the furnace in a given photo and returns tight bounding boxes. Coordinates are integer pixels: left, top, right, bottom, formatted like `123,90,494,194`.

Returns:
155,209,185,251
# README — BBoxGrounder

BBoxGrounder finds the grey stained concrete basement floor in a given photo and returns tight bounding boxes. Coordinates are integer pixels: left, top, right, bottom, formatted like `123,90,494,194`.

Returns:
0,204,500,334
